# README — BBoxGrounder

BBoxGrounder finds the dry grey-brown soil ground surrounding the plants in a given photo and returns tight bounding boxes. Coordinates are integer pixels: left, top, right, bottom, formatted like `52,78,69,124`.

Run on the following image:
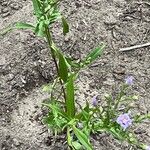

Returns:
0,0,150,150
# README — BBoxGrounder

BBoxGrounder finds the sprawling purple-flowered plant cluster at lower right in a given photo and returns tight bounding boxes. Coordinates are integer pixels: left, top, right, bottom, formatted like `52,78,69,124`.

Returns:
89,76,150,150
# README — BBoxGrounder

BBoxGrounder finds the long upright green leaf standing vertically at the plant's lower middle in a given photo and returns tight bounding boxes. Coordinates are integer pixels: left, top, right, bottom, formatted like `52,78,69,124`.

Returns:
66,74,75,117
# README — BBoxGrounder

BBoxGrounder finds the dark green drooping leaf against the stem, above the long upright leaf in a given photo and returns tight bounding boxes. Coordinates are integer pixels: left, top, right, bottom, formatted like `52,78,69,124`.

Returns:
58,52,68,83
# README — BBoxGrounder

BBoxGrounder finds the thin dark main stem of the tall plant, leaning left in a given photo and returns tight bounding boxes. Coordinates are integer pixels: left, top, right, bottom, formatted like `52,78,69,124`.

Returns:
45,27,66,110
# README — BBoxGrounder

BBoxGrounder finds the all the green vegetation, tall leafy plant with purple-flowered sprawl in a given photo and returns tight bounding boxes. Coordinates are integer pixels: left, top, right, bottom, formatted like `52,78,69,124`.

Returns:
2,0,150,150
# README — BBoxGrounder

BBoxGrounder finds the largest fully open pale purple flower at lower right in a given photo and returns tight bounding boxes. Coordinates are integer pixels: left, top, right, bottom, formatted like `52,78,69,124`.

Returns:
117,113,132,130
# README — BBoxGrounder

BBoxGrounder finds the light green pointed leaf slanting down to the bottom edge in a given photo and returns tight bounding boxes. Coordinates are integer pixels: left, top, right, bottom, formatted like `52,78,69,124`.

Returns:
72,126,93,150
